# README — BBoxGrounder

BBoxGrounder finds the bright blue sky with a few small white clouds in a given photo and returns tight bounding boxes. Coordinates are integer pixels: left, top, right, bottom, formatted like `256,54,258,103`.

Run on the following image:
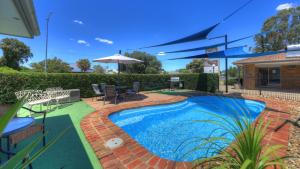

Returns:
0,0,297,71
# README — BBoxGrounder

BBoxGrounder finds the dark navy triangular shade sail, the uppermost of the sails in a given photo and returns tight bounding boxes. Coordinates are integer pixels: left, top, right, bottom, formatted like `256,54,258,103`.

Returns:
141,23,219,49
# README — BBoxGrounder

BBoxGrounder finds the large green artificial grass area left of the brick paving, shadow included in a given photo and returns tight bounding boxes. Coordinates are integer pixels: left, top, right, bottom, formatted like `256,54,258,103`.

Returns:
4,101,102,169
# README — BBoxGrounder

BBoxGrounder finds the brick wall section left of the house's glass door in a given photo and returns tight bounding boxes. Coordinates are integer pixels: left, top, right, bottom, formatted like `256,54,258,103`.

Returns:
243,64,257,89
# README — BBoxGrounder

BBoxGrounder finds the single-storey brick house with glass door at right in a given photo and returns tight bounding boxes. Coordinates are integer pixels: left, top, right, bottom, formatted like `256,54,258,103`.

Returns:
234,52,300,90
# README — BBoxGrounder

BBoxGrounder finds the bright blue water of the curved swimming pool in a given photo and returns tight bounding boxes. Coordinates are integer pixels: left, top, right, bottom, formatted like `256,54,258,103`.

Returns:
109,96,265,161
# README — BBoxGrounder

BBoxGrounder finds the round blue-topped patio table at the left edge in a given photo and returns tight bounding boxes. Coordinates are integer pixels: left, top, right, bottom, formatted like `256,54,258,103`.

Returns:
0,117,34,159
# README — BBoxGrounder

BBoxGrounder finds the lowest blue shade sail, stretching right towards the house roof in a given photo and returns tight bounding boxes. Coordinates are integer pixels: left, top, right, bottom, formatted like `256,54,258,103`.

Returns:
169,47,286,60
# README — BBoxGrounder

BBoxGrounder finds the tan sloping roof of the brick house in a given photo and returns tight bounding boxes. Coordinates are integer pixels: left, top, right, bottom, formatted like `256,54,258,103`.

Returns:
233,53,300,65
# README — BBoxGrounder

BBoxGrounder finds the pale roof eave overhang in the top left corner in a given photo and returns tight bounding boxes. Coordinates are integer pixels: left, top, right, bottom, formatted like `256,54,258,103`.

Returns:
0,0,40,38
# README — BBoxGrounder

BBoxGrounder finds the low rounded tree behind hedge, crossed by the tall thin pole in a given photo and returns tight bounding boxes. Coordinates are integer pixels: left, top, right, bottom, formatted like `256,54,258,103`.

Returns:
31,57,72,73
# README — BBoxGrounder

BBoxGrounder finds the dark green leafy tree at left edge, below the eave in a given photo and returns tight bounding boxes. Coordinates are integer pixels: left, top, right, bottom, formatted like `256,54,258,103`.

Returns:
0,38,33,70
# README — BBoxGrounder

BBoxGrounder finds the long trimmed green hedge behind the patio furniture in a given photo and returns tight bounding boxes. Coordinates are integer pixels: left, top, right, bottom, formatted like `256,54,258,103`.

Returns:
0,72,218,104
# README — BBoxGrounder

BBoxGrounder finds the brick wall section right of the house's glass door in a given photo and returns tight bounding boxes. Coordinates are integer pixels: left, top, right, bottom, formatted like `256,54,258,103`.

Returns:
280,65,300,89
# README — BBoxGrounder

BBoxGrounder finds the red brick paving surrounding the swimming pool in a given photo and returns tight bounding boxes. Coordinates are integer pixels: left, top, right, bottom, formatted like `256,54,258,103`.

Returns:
81,93,299,169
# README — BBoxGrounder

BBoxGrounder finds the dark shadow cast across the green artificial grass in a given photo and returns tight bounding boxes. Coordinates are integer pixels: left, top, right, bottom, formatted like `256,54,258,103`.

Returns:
1,115,93,169
